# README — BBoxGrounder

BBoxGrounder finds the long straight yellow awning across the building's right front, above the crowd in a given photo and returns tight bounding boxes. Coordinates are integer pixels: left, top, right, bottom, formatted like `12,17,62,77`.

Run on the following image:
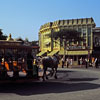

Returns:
59,50,91,55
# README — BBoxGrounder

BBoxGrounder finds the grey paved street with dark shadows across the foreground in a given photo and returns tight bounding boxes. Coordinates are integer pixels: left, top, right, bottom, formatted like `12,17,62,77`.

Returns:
0,68,100,100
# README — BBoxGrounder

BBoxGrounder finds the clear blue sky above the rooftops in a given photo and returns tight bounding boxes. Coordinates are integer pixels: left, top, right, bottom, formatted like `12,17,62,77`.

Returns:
0,0,100,41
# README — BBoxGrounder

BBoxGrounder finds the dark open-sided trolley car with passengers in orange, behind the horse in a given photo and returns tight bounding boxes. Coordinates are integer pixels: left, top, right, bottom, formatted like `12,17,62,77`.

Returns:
0,40,38,80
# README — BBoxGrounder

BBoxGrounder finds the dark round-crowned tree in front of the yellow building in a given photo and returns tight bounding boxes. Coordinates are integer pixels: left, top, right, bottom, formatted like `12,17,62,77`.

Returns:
51,29,83,60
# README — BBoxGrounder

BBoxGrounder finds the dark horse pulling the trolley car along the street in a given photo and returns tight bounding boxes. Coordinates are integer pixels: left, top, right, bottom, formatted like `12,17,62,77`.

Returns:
42,56,59,81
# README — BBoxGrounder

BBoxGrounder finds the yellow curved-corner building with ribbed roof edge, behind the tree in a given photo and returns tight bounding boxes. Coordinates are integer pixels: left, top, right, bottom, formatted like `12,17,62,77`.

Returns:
38,18,100,64
